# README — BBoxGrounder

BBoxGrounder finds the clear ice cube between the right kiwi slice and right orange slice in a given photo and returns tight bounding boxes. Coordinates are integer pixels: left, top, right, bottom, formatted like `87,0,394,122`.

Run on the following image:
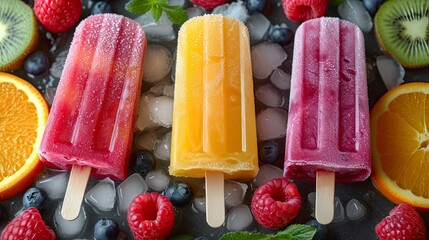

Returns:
377,55,405,89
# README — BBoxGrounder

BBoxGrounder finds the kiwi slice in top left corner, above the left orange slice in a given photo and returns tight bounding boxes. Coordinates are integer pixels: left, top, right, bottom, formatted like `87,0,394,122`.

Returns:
0,0,38,71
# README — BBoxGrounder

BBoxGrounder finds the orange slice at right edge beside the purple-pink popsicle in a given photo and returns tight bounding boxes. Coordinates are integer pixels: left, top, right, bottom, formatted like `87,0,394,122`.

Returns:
371,83,429,211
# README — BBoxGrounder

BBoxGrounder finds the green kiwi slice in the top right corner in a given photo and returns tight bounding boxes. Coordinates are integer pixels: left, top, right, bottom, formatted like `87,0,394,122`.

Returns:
374,0,429,68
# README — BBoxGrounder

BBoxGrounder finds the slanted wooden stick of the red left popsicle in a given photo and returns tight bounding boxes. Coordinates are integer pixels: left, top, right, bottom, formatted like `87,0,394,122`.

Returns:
61,165,91,221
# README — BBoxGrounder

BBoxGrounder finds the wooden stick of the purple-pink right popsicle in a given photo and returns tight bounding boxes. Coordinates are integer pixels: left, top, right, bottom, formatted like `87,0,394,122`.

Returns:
316,171,335,224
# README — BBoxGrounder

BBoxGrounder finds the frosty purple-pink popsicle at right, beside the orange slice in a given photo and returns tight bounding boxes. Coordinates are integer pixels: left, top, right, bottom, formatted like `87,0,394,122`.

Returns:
284,18,371,221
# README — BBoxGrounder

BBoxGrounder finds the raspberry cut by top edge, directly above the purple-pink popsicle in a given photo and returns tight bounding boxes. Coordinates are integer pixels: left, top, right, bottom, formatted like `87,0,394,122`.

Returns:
282,0,328,22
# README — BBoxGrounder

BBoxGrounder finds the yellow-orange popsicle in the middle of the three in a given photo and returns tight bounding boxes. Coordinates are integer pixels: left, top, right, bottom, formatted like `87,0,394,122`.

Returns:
169,15,258,226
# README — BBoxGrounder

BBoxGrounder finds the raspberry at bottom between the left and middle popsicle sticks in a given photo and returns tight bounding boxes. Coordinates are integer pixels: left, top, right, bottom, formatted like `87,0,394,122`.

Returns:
127,192,174,240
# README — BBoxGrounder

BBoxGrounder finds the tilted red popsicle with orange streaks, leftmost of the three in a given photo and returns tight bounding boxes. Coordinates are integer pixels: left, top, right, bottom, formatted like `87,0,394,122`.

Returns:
39,14,146,217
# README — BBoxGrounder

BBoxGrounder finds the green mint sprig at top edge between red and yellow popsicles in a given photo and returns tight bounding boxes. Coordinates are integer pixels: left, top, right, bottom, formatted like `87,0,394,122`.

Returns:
125,0,188,25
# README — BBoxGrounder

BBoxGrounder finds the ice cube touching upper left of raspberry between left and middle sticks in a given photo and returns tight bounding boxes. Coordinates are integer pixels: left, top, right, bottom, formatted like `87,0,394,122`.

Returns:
117,173,148,213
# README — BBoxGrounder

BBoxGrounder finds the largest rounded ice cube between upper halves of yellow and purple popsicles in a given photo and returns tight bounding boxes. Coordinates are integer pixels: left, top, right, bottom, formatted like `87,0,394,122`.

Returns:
251,42,287,79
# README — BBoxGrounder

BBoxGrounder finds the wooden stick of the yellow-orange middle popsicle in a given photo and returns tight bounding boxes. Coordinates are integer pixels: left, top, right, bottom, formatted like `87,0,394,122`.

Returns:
206,171,225,228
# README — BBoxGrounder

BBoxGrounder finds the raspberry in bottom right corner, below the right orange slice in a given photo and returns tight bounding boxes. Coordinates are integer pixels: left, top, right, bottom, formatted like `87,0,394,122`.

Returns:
375,203,427,240
